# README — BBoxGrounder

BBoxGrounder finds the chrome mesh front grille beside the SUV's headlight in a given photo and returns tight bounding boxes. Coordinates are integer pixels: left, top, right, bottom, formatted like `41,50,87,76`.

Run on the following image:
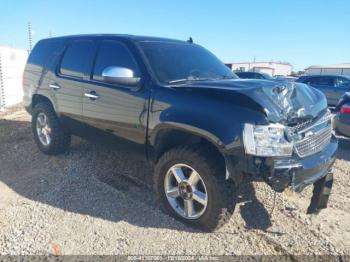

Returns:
294,112,332,157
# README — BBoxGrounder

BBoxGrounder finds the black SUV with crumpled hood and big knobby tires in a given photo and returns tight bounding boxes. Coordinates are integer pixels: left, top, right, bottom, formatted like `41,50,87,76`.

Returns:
23,35,337,230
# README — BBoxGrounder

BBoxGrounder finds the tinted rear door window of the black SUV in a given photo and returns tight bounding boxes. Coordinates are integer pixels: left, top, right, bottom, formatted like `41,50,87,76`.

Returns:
60,40,94,78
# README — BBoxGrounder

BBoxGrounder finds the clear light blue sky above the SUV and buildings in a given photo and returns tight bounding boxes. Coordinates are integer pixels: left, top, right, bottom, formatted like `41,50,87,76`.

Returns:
0,0,350,71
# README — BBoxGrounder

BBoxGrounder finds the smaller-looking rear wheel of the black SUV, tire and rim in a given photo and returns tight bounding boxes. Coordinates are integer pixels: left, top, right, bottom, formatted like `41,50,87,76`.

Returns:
32,103,71,155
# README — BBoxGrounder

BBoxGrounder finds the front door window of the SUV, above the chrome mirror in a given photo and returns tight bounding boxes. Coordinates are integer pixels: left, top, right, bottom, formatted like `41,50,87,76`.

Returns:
93,41,140,81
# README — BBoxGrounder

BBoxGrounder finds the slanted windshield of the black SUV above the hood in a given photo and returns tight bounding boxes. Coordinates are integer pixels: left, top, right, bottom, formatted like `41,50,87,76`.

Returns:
140,42,238,84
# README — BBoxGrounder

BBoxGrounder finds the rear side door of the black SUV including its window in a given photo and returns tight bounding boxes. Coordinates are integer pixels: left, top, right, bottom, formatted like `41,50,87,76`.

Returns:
49,40,95,124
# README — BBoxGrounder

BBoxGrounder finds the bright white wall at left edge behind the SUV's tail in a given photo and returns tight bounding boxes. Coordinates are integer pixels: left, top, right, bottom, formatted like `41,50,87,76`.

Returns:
0,46,28,111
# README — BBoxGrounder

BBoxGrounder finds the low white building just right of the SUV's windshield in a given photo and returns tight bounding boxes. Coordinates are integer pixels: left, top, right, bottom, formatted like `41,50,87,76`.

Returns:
226,61,293,76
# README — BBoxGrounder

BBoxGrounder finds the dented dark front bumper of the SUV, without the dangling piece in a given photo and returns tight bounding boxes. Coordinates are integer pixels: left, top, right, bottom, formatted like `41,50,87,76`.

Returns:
225,136,338,192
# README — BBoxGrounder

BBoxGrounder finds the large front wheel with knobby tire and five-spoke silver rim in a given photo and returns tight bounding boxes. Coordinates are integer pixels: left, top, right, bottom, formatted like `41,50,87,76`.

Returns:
154,145,236,231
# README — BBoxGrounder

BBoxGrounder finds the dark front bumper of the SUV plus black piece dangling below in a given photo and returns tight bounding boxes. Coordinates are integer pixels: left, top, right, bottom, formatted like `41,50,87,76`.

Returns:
226,136,338,214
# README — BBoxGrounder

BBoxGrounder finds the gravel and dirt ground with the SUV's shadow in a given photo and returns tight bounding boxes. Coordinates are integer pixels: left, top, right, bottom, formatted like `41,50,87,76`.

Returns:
0,104,350,255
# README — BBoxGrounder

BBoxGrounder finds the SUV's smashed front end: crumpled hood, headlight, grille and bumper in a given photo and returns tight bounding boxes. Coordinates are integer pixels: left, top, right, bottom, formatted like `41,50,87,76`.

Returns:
186,79,338,212
